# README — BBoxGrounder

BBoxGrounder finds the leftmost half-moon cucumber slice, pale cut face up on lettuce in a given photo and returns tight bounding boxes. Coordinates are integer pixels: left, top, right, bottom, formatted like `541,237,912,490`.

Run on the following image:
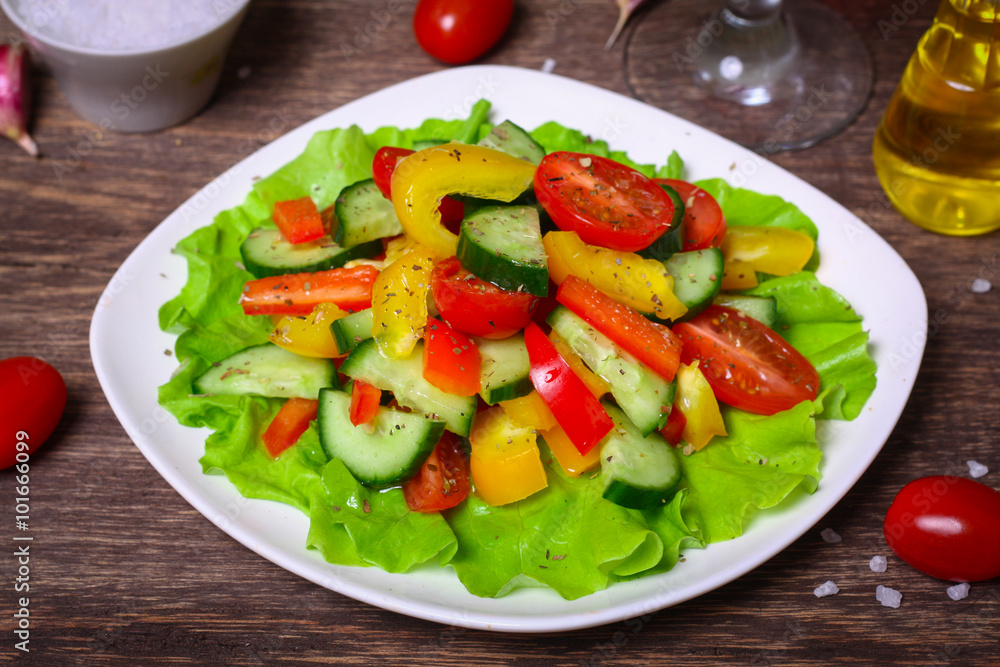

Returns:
194,343,340,398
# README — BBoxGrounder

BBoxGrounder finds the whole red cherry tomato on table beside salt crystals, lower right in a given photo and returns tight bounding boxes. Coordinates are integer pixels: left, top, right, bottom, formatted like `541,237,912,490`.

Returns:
882,475,1000,581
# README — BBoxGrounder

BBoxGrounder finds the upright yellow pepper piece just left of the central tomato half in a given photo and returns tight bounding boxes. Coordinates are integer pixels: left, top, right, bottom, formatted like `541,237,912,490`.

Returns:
372,245,434,359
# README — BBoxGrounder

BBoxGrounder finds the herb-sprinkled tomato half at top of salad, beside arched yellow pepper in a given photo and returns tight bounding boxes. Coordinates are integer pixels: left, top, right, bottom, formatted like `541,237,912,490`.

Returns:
535,152,674,252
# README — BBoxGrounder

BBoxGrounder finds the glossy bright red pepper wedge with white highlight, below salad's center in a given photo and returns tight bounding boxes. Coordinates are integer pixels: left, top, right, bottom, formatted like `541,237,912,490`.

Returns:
524,322,614,455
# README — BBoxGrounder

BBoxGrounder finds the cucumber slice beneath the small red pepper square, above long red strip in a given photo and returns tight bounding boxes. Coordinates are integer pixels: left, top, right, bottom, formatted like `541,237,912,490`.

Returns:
240,227,382,278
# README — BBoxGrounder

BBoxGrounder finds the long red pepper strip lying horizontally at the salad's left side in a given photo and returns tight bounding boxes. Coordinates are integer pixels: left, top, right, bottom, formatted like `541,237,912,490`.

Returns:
240,264,378,315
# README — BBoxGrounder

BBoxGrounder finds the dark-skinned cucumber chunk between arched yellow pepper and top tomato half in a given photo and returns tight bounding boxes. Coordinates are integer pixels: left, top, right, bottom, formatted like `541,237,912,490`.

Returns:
455,206,549,296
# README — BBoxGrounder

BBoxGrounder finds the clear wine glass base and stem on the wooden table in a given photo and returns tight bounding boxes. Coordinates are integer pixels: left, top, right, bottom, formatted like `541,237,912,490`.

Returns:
624,0,873,153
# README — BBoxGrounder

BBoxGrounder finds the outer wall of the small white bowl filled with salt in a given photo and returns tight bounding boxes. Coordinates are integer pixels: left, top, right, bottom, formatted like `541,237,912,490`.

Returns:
0,0,250,132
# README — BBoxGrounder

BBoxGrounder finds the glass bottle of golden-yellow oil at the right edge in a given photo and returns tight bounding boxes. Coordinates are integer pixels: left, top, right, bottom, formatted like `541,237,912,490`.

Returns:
873,0,1000,236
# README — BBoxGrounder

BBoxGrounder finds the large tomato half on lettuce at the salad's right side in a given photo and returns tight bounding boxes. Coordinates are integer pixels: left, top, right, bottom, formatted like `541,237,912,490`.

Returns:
674,306,819,415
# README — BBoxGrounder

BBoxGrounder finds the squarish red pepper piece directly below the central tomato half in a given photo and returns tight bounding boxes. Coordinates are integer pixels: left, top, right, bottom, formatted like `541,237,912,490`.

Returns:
424,317,482,396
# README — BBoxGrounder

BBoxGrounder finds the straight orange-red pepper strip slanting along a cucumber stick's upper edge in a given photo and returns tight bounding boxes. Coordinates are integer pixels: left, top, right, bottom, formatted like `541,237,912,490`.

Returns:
556,275,681,382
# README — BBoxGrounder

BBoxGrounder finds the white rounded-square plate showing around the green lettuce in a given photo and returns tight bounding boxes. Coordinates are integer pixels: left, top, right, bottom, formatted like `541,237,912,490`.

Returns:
90,66,927,632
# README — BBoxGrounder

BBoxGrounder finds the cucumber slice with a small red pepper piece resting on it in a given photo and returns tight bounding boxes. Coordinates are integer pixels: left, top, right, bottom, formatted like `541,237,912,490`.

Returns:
317,389,444,488
